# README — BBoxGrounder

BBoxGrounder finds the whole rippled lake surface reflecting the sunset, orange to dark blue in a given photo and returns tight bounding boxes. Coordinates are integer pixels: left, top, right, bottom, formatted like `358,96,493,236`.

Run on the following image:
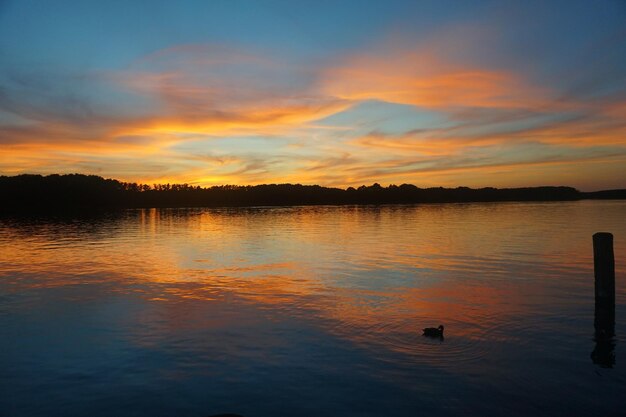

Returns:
0,201,626,417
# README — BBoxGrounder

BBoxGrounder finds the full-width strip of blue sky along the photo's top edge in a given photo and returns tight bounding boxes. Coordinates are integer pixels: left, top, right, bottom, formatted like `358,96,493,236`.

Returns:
0,0,626,80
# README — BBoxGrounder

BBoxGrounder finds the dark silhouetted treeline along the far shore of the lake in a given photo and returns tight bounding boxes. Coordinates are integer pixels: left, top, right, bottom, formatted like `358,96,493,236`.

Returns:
0,174,626,212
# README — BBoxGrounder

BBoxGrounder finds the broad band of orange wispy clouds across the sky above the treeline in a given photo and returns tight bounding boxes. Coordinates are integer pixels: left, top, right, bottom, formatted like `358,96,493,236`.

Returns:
0,19,626,186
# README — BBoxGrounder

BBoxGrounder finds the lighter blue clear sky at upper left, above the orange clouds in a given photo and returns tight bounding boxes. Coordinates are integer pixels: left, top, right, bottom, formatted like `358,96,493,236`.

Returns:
0,0,492,69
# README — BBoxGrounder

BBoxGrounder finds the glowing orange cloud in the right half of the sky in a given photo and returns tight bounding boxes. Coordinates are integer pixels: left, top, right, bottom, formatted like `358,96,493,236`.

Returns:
322,47,546,110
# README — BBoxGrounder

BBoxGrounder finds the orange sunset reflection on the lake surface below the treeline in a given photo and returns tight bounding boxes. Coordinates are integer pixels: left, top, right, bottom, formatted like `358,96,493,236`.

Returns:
0,202,624,366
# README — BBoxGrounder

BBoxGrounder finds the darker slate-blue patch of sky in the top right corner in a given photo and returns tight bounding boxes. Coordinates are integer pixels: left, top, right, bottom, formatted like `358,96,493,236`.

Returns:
468,0,626,91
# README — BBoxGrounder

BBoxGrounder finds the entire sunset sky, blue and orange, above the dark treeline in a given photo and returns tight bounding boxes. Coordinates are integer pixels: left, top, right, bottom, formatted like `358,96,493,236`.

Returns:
0,0,626,191
